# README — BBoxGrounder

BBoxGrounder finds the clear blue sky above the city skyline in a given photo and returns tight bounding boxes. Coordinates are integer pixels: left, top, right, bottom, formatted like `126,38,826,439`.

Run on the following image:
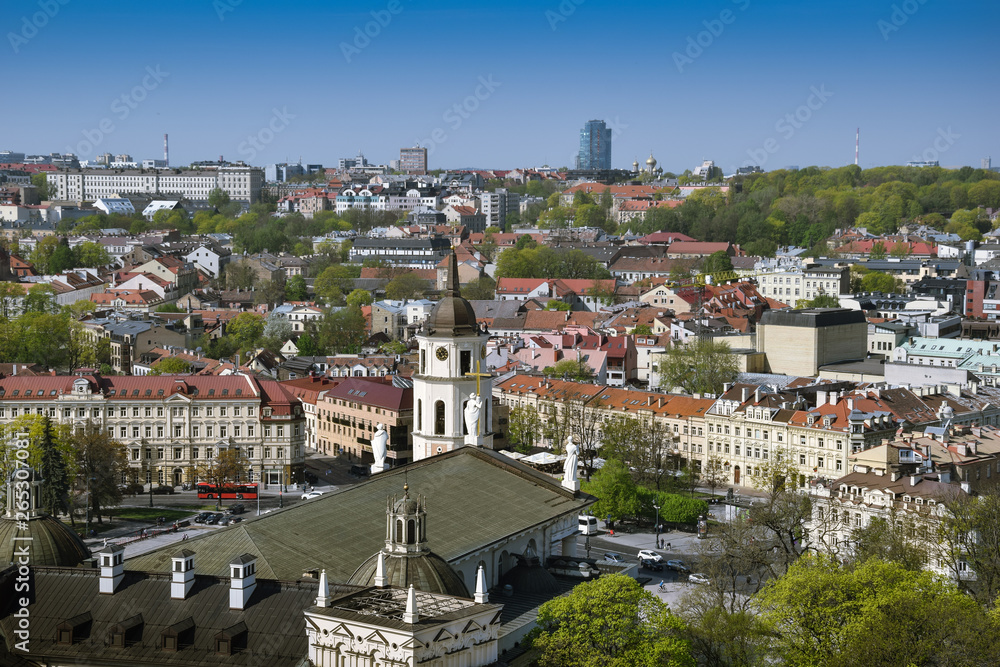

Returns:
7,0,1000,172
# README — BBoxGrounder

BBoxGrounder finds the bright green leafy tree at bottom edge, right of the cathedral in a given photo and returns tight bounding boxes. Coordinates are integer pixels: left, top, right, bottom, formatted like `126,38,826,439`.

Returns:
532,574,695,667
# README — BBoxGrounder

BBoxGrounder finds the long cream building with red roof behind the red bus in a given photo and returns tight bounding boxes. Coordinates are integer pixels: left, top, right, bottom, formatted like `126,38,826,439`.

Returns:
0,375,306,486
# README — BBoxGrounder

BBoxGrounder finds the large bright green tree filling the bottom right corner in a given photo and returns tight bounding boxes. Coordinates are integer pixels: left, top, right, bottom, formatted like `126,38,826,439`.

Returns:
757,556,997,667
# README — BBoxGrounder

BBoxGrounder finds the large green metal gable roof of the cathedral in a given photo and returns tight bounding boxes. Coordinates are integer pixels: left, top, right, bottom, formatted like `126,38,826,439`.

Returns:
125,447,595,582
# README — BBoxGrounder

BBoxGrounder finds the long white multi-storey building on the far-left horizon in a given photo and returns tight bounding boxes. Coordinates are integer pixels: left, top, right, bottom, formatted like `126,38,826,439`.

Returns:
46,166,264,204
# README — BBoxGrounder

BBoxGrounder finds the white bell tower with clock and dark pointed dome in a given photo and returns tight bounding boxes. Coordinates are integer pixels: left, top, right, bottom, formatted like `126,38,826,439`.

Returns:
413,252,493,461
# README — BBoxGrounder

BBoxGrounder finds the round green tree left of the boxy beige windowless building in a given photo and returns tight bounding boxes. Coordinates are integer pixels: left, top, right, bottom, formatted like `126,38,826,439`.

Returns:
657,338,739,394
